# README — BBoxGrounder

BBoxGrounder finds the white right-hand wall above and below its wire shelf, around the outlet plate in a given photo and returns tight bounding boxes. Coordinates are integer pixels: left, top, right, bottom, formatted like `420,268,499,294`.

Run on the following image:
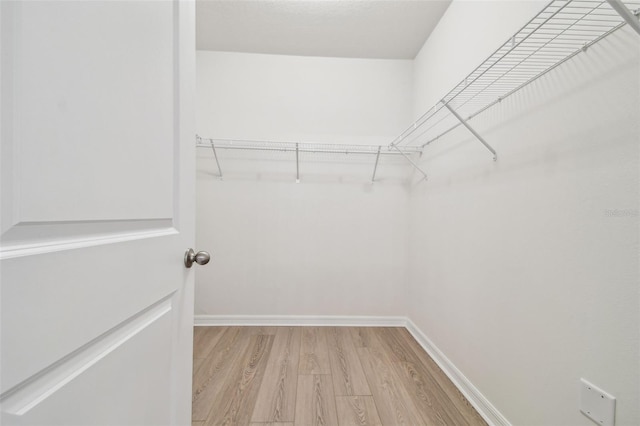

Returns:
408,1,640,426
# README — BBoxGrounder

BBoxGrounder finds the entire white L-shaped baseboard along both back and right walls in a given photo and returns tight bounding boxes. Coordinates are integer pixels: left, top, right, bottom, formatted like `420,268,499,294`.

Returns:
194,315,511,426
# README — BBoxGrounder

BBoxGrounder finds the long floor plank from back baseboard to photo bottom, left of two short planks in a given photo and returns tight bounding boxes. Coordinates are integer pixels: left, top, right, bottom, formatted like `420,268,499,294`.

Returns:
251,327,302,422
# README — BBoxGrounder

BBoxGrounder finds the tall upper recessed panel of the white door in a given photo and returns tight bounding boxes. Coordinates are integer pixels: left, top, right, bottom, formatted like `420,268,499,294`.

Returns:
3,1,178,224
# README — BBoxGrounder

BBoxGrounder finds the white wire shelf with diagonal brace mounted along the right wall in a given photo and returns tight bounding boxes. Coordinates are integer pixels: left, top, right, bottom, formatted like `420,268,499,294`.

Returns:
389,0,640,160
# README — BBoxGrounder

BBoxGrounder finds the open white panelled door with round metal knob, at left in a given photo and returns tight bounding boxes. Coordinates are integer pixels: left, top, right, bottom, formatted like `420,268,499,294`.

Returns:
0,0,195,425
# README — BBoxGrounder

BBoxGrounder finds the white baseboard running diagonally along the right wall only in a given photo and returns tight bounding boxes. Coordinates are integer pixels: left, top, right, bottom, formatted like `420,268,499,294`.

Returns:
406,318,511,426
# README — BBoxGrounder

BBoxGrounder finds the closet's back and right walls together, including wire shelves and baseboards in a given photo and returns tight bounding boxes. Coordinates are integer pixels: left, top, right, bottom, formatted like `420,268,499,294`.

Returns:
195,0,640,424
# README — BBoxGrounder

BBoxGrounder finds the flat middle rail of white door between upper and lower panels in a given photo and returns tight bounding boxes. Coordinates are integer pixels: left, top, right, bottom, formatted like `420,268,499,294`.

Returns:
1,237,184,392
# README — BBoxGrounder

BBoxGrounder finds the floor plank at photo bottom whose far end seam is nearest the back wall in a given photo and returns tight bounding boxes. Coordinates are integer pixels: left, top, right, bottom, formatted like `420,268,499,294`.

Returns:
294,374,338,426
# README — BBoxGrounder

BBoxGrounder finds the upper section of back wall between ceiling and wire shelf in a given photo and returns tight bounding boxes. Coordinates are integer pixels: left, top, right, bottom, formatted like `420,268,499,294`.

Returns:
197,51,413,144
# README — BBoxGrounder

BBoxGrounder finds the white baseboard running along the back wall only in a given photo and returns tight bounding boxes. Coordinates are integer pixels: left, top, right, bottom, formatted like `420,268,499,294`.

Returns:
194,315,407,327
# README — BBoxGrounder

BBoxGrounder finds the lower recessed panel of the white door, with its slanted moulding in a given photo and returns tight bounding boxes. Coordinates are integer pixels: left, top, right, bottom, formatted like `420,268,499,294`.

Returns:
3,299,171,425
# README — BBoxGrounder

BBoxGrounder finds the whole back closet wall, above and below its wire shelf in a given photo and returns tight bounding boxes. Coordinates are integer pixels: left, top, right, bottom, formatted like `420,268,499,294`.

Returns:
196,52,412,315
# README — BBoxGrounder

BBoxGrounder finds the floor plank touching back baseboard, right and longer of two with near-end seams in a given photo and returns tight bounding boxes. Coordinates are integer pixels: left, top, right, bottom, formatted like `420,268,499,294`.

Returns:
326,327,371,395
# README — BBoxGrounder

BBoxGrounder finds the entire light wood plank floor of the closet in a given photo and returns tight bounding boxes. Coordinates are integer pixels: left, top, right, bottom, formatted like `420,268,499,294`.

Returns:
193,327,486,426
